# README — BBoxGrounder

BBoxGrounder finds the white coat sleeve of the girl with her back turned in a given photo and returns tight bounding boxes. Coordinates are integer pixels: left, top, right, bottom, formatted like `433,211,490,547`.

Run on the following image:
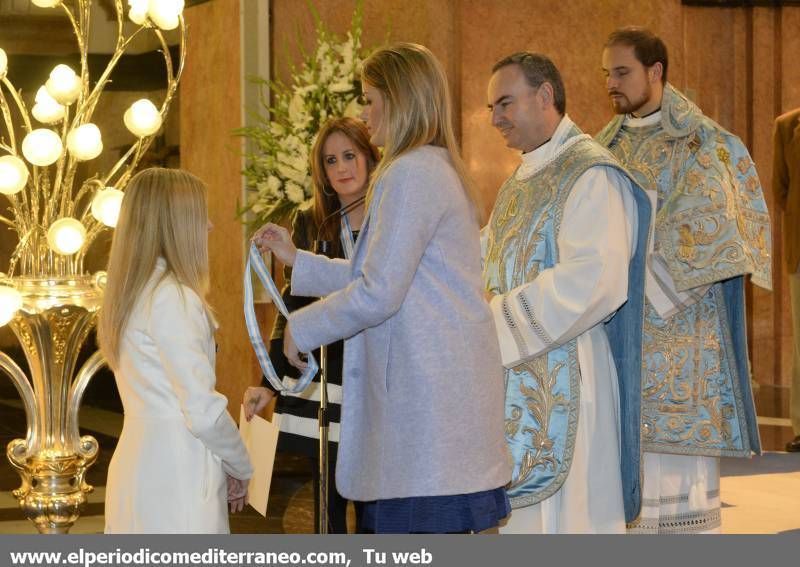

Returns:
149,280,253,480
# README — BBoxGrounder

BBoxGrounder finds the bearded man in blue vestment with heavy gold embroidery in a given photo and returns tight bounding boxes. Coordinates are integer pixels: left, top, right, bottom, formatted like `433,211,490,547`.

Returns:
597,27,771,533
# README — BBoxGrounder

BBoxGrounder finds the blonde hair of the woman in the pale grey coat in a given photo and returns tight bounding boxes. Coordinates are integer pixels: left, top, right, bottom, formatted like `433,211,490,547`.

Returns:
361,43,483,220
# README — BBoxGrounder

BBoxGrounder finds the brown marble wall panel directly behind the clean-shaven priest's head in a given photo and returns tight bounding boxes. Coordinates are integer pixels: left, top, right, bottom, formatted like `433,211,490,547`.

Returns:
459,0,682,215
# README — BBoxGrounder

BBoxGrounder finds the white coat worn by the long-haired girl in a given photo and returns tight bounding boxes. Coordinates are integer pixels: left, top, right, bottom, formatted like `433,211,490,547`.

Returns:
105,259,252,533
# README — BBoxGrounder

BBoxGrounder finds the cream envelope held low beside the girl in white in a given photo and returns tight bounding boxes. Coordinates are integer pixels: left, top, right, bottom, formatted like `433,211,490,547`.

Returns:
239,406,280,517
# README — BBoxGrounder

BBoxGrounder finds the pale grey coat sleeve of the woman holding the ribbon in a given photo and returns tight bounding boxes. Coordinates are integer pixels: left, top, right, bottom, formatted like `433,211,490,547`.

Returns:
289,158,450,352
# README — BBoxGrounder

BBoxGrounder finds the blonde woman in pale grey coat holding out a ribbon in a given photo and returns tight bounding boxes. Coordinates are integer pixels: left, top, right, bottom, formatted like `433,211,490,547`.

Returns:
255,43,511,533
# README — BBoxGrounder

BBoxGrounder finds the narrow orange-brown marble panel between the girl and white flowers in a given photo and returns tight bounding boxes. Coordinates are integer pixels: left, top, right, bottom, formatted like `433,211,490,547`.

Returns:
180,0,256,418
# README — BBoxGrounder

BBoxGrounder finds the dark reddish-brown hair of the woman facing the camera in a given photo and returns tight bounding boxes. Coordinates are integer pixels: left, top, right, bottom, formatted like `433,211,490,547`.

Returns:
311,117,381,249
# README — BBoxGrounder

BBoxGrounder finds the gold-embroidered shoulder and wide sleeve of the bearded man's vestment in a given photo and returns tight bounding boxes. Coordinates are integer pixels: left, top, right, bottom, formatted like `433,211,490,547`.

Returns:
611,119,771,291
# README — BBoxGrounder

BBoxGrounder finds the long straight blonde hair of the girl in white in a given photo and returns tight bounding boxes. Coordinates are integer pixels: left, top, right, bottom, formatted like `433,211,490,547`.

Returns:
97,168,211,369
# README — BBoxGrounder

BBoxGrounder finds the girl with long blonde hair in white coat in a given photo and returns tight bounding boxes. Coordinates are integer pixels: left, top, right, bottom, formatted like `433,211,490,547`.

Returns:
98,168,252,533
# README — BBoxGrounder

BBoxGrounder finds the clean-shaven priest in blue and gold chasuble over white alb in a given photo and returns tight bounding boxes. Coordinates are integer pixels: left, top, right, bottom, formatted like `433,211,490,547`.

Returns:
484,52,650,533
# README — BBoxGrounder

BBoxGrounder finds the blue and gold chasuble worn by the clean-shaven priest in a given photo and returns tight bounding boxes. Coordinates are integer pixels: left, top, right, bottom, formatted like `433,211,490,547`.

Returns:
484,126,650,521
